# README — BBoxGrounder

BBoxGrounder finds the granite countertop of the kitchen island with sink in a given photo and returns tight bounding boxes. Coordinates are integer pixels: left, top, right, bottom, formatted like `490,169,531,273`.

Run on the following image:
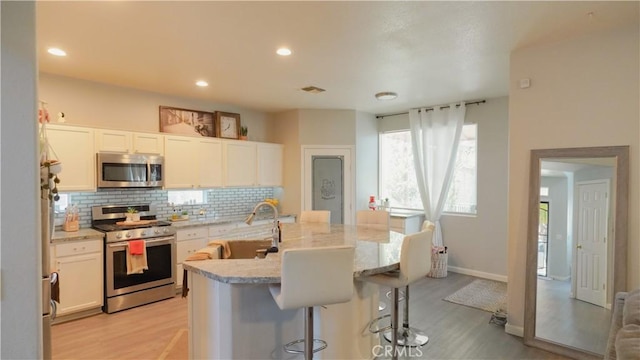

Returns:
183,224,404,284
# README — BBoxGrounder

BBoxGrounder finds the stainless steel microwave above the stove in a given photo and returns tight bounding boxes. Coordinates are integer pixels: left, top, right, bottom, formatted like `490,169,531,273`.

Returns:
97,153,164,188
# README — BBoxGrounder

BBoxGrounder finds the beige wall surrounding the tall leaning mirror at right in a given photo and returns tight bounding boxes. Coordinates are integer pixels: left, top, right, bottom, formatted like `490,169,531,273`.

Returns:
508,21,640,332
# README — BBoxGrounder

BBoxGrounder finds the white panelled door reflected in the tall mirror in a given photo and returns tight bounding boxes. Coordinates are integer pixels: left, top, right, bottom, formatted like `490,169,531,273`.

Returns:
576,180,609,307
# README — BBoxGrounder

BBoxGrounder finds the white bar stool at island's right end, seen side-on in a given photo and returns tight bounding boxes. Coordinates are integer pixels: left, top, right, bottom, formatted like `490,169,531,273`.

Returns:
361,229,433,359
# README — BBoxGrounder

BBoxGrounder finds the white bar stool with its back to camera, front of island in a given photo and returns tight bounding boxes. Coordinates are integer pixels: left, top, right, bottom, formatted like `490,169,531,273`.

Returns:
269,246,355,359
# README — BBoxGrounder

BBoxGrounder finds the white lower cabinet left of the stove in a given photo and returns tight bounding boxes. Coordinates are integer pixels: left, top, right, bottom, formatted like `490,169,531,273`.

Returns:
52,238,103,316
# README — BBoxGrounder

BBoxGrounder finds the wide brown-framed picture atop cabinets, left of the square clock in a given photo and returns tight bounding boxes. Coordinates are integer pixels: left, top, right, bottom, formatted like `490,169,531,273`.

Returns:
159,106,216,137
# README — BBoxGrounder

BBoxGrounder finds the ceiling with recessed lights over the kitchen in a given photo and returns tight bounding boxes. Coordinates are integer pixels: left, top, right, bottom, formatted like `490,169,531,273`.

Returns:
37,1,639,114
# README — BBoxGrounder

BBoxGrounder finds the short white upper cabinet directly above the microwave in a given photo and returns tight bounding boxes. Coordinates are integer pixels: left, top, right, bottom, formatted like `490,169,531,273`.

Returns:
95,129,164,155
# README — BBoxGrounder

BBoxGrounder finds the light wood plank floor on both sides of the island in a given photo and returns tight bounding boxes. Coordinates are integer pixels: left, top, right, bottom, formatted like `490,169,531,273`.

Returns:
52,273,565,360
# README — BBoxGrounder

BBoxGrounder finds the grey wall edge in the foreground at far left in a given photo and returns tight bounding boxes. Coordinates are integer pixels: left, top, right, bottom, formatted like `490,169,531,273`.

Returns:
0,1,43,359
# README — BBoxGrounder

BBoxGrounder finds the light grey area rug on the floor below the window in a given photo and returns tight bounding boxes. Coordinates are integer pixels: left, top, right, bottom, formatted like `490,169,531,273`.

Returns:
444,279,507,312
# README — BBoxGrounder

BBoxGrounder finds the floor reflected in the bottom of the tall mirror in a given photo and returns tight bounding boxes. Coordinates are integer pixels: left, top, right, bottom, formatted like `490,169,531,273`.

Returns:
536,279,611,356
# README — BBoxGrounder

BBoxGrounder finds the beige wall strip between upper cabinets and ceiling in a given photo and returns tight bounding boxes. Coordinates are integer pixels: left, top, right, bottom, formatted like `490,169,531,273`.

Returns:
38,73,272,141
